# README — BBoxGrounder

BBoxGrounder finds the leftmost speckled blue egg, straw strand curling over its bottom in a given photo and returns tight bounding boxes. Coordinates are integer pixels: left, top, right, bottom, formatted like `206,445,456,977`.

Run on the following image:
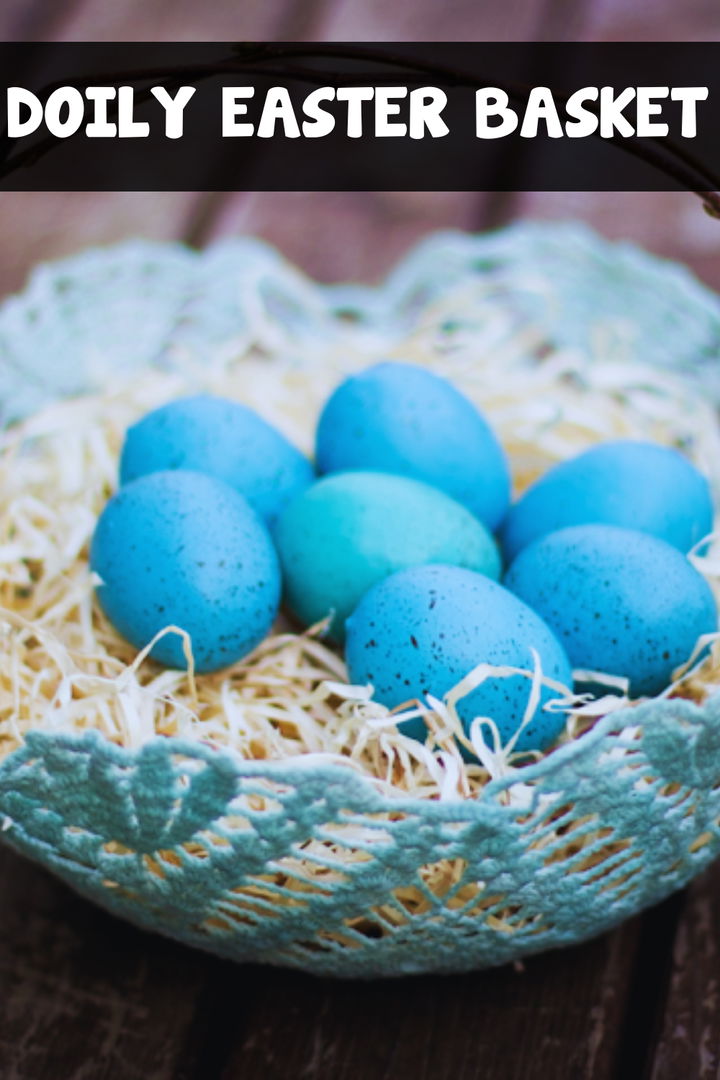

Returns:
91,470,281,672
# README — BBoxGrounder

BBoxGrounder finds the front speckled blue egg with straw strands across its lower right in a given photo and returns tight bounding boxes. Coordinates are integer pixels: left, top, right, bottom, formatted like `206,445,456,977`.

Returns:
345,566,572,751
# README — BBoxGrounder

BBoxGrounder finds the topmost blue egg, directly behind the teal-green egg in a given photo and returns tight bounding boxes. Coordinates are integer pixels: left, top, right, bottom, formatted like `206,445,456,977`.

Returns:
317,363,510,530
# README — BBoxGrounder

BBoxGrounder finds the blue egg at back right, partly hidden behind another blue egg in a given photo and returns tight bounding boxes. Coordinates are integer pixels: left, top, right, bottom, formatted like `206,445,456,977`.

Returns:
500,440,712,562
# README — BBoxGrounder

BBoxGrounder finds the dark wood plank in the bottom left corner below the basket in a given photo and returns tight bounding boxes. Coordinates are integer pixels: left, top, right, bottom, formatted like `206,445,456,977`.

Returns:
0,850,223,1080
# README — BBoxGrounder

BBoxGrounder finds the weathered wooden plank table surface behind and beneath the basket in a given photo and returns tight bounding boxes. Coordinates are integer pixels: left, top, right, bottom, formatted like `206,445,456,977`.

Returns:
0,0,720,1080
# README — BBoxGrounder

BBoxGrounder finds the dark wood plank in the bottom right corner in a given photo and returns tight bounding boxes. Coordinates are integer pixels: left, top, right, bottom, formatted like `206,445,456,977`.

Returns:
651,863,720,1080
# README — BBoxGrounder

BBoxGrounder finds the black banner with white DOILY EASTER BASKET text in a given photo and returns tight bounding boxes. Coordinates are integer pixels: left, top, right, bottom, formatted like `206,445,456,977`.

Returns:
0,42,720,191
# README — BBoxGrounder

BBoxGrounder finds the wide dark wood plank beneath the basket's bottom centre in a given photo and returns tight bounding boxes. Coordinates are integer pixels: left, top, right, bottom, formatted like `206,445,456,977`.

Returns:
220,920,638,1080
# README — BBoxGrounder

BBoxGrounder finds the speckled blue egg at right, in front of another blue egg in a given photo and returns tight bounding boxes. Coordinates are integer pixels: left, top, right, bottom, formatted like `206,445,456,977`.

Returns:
505,525,718,697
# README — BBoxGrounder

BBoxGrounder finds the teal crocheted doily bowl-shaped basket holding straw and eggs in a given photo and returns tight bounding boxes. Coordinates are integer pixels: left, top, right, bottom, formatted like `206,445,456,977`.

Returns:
0,225,720,976
